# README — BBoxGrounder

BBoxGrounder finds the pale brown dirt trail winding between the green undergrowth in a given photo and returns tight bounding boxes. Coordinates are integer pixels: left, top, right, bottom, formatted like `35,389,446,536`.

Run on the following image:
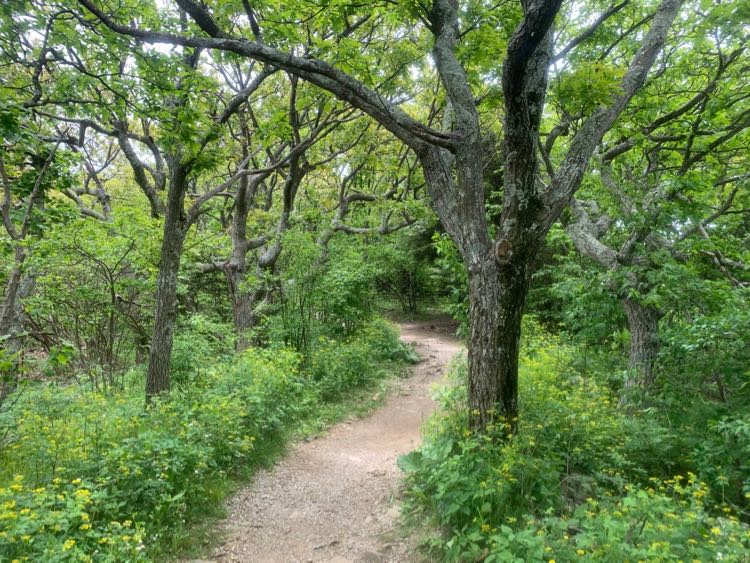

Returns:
206,320,461,563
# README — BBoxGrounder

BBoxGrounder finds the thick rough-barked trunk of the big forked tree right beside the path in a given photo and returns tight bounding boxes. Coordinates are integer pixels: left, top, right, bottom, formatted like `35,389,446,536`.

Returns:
422,141,538,434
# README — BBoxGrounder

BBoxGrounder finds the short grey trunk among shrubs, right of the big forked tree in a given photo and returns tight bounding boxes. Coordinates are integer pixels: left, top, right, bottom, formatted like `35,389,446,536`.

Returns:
622,299,662,388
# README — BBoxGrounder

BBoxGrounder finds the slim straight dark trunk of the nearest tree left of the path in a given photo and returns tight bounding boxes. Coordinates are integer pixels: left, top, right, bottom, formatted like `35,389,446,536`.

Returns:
146,164,187,399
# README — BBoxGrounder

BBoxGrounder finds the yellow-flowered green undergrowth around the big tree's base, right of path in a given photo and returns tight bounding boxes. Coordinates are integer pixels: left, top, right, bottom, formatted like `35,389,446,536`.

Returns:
399,325,750,562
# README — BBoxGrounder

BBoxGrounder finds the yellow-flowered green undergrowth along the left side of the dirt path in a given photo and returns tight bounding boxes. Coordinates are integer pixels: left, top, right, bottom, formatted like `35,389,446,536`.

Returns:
0,320,413,562
